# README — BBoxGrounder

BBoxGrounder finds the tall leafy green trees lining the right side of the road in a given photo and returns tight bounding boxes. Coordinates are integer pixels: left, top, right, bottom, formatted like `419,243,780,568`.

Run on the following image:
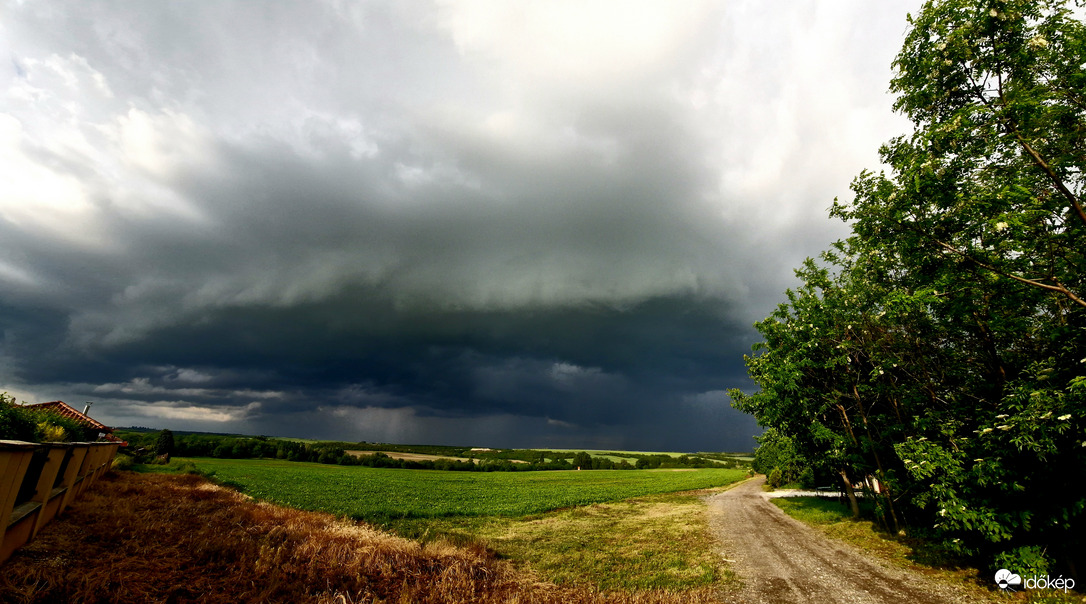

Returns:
734,0,1086,572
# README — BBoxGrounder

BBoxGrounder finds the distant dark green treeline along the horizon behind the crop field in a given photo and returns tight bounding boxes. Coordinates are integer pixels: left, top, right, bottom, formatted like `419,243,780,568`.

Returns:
115,429,745,471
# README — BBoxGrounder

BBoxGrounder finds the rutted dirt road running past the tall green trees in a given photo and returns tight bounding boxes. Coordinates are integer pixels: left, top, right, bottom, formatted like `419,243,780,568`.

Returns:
708,478,990,604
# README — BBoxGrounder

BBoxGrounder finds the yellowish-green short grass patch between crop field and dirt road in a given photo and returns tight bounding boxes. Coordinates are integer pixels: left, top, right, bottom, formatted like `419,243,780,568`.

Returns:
391,492,734,591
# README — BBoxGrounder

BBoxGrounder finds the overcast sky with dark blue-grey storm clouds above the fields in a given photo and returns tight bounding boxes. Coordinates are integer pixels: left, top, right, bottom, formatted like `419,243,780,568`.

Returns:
0,0,920,451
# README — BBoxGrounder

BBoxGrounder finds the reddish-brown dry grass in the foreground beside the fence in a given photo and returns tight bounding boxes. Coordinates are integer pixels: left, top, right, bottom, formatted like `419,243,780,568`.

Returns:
0,473,711,604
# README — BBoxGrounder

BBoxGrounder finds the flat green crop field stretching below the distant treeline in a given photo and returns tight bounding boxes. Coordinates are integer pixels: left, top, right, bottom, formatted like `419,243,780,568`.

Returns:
191,458,746,521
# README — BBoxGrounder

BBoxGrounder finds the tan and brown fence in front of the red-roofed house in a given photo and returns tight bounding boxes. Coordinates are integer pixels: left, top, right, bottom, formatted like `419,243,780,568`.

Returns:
0,440,119,563
